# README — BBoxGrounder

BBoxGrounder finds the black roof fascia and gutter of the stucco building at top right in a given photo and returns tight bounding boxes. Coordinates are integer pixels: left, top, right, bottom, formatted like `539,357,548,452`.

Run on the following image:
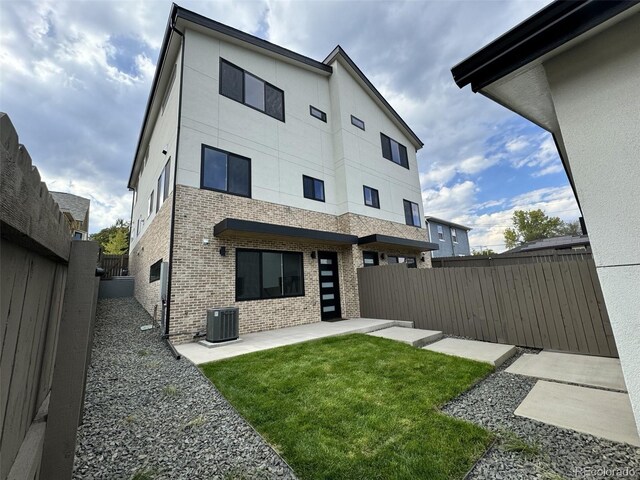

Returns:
451,0,639,92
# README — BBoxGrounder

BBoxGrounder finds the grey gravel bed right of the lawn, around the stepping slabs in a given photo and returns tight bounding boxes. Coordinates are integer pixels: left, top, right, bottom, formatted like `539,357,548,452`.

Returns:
443,349,640,480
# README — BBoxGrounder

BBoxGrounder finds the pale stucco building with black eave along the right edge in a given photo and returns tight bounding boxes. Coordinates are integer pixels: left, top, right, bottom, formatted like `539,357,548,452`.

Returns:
452,1,640,436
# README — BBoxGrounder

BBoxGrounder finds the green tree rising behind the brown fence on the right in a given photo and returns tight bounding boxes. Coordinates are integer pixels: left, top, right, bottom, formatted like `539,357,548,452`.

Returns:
504,209,580,249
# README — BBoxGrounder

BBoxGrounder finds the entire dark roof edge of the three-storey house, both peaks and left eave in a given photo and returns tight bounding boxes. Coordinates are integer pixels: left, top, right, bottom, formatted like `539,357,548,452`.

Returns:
128,3,424,188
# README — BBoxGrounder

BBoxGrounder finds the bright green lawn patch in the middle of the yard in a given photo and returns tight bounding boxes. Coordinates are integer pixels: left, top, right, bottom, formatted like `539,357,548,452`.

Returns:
202,334,493,480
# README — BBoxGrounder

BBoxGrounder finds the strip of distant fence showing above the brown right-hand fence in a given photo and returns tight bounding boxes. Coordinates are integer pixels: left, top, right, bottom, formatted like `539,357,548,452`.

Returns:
431,251,592,268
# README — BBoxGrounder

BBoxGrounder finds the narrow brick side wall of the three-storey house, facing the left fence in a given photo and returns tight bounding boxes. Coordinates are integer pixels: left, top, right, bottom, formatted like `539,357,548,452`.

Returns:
129,194,173,321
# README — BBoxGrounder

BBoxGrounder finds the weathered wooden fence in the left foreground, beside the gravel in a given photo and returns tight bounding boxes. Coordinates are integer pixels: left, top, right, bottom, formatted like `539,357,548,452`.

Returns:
0,113,98,480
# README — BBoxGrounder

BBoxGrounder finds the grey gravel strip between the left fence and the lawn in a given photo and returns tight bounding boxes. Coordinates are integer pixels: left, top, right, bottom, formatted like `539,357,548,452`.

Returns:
73,298,295,480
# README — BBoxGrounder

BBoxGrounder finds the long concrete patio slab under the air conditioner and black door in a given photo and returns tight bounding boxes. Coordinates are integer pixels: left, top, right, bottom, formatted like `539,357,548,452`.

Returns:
175,318,413,365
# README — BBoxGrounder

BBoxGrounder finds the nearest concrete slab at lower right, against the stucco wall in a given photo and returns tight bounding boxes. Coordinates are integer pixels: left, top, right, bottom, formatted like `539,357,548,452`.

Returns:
515,380,640,447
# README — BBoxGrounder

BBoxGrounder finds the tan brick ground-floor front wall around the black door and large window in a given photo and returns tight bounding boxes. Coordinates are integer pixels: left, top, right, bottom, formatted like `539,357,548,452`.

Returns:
168,185,430,343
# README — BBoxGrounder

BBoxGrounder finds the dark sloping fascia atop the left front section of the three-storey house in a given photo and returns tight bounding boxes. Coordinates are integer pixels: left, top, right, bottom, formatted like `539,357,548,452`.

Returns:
176,6,333,74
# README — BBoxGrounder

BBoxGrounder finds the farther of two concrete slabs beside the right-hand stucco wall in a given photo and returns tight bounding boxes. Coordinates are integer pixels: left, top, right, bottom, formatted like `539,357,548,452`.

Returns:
506,351,627,392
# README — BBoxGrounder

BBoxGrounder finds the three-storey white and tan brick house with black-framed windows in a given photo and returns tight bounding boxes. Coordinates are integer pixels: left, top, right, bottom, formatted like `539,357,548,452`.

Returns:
128,5,437,342
